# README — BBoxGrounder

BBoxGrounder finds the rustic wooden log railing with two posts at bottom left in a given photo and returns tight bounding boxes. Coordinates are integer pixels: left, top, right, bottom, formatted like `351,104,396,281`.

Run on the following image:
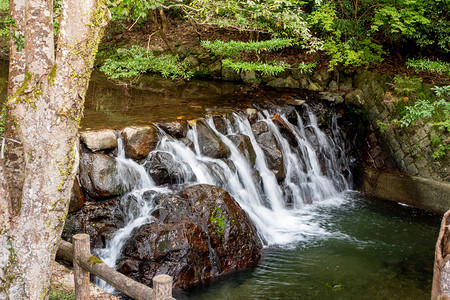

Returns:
56,234,175,300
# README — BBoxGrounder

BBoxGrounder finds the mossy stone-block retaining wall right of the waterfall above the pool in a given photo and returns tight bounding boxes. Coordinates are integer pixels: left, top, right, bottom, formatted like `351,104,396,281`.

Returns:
345,71,450,182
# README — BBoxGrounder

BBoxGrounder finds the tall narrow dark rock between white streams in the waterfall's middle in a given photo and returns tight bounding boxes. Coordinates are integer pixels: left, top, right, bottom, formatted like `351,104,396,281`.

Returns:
252,121,285,181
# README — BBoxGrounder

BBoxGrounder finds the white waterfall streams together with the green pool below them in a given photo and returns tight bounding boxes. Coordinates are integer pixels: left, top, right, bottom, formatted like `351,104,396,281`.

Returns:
91,104,439,299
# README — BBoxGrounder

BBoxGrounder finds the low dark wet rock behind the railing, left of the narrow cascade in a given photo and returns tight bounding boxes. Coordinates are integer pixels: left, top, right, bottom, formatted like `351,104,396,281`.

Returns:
62,199,124,249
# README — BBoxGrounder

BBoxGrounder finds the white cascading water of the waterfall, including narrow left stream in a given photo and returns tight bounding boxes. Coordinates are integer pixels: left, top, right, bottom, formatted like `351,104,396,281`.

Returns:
98,106,349,290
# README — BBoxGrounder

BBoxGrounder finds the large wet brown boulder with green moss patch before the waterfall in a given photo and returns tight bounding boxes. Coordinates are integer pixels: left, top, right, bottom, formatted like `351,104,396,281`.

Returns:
118,185,262,288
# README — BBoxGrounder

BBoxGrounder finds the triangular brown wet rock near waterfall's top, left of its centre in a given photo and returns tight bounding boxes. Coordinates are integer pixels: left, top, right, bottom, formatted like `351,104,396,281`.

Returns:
196,120,230,158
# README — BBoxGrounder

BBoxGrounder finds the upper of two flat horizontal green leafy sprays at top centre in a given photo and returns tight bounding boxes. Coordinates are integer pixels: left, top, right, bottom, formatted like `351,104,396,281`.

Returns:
201,38,294,56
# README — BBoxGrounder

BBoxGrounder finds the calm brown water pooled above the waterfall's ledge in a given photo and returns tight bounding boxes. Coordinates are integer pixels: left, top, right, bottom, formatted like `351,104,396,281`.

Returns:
81,72,256,129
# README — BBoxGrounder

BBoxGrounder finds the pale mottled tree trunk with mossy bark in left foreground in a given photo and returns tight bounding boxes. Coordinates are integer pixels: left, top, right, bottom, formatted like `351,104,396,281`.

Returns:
0,0,110,300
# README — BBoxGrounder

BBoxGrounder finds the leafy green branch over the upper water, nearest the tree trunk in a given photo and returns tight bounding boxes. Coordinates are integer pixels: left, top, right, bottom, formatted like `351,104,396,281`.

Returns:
100,46,192,79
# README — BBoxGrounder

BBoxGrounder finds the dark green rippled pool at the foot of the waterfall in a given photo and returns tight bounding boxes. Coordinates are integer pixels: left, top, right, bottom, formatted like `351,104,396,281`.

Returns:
175,192,440,299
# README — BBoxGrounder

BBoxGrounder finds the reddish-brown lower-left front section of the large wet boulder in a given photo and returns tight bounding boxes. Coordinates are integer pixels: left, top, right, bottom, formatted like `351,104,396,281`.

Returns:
117,219,211,288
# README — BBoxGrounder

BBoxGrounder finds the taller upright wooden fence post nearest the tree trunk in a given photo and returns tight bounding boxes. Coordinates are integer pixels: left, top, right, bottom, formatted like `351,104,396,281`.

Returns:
72,233,91,300
